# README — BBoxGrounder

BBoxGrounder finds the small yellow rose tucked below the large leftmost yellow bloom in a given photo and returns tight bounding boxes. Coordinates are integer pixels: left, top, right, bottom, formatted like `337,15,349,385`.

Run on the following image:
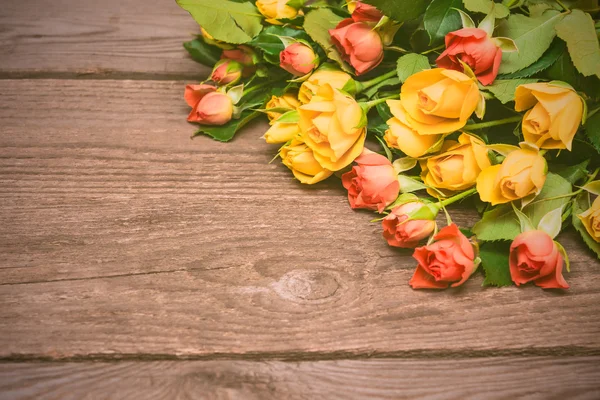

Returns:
279,139,333,185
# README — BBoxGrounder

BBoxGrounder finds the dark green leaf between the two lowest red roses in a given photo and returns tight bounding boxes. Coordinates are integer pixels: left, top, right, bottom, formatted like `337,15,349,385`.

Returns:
479,242,513,287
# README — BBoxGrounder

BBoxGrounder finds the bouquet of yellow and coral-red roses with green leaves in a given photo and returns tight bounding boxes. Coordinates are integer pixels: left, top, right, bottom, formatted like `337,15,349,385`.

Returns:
177,0,600,289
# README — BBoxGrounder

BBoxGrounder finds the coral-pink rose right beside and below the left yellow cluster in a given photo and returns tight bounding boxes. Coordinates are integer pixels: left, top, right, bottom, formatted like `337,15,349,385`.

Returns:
342,149,400,212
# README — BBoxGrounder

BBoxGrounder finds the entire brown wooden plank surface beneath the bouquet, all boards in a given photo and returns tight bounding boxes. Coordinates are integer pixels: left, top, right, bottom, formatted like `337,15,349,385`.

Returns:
0,0,600,399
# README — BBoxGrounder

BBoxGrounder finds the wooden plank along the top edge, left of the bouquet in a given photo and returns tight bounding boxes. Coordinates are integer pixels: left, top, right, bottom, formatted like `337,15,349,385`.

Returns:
0,0,208,78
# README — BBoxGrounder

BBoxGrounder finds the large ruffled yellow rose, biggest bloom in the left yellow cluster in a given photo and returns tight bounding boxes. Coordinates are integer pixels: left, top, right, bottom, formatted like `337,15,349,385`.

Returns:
298,84,367,171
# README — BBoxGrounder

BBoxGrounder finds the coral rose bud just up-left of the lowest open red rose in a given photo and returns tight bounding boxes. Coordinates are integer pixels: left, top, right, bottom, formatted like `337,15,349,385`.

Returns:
382,201,435,249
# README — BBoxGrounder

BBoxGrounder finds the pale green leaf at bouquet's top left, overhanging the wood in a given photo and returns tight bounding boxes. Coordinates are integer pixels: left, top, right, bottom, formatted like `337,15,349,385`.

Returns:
177,0,262,43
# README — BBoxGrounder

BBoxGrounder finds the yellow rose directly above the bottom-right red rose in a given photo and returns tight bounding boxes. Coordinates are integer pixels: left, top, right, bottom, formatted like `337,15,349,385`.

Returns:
477,149,548,205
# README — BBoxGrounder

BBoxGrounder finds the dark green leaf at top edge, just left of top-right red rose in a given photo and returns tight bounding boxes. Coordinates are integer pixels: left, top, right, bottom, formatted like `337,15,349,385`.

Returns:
423,0,462,45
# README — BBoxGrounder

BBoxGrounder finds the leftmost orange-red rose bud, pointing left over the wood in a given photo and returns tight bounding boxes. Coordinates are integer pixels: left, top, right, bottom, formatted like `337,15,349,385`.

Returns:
184,85,233,125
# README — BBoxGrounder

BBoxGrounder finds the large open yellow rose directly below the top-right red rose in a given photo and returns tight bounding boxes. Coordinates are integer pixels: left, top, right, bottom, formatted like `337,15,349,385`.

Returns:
400,68,481,135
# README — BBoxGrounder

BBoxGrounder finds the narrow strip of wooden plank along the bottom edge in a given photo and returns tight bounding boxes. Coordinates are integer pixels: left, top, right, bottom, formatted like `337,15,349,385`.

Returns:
0,357,600,400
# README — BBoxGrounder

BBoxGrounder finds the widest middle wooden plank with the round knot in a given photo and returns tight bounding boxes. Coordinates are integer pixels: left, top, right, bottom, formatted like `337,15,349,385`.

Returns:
0,80,600,359
